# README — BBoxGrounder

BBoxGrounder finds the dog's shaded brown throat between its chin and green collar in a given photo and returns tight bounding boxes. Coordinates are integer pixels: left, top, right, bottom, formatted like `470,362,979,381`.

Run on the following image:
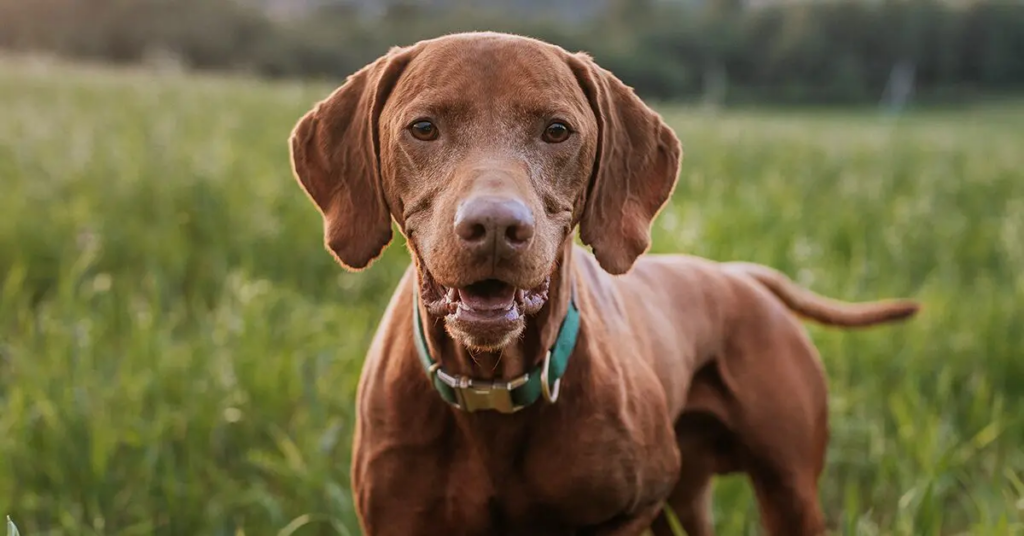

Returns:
420,238,572,380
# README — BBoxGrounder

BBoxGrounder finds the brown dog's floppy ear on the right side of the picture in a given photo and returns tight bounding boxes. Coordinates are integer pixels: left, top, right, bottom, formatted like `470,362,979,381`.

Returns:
568,53,682,275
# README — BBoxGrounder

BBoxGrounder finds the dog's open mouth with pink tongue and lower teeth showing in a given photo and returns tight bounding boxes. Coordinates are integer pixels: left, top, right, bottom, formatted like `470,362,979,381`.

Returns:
422,278,551,327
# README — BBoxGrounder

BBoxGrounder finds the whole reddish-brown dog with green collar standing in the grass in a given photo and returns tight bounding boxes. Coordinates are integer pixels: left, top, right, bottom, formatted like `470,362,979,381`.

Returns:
291,33,918,536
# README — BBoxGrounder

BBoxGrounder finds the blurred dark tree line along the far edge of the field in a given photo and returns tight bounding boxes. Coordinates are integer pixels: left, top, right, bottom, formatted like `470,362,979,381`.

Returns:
0,0,1024,104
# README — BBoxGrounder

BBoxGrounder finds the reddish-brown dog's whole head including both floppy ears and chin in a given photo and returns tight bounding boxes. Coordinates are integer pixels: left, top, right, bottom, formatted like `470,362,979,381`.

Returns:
291,33,681,349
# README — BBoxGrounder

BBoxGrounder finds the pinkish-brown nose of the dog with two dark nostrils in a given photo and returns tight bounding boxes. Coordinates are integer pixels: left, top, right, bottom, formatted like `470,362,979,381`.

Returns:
455,197,534,255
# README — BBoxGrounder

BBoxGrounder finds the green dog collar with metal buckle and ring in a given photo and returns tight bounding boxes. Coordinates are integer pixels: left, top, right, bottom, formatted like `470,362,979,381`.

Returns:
413,288,580,413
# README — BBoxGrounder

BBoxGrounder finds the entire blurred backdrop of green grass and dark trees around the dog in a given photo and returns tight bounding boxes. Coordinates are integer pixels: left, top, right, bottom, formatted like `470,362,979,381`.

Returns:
0,0,1024,536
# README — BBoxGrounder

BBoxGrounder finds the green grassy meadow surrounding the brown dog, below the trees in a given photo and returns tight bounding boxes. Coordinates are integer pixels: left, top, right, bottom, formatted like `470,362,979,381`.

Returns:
0,56,1024,536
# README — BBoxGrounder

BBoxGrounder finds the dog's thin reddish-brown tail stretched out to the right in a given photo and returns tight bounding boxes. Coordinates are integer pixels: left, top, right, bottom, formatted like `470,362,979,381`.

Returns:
723,262,921,327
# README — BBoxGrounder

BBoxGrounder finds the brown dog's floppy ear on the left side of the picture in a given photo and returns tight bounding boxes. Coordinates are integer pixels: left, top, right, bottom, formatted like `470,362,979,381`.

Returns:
289,48,413,271
